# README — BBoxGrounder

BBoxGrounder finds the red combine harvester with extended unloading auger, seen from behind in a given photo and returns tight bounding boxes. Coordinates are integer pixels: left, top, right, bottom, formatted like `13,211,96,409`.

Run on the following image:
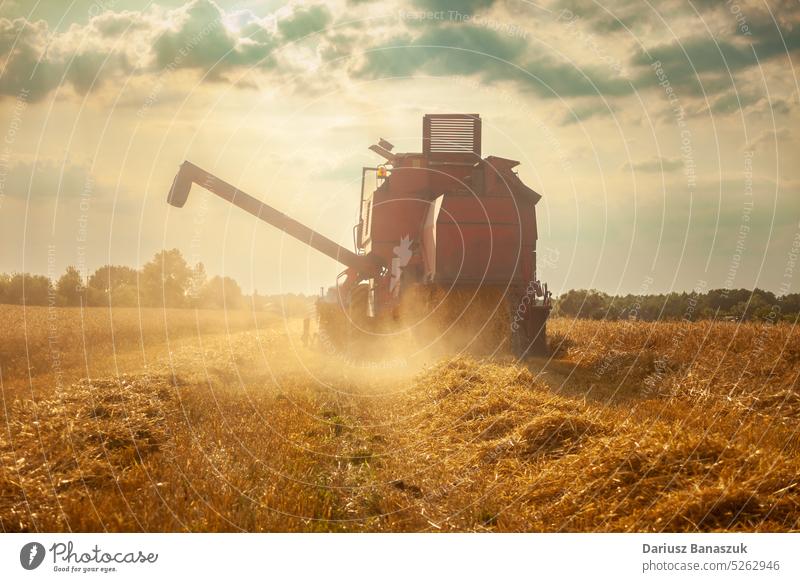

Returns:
168,114,550,356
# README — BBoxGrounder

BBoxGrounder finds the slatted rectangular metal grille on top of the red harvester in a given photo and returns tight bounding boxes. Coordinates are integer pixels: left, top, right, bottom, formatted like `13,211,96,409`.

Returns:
422,114,481,157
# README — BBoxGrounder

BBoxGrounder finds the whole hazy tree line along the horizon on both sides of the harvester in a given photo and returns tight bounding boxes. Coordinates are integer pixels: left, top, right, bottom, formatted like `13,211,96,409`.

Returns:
0,249,800,321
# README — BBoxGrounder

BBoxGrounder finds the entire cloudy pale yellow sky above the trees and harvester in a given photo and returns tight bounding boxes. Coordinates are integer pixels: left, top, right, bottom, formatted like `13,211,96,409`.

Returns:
0,0,800,294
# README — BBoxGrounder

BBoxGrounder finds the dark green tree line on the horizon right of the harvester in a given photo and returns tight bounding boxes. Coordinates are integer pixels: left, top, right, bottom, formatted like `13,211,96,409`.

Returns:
553,288,800,322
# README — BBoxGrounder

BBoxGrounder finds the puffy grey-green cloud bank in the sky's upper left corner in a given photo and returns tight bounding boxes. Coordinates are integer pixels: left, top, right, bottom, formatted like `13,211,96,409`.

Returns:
0,0,322,101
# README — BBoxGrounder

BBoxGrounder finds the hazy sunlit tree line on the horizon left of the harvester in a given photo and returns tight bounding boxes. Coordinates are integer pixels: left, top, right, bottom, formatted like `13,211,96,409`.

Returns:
0,249,308,312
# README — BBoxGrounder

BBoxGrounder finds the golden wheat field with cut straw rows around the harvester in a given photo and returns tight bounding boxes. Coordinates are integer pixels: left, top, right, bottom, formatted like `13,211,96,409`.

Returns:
0,306,800,532
